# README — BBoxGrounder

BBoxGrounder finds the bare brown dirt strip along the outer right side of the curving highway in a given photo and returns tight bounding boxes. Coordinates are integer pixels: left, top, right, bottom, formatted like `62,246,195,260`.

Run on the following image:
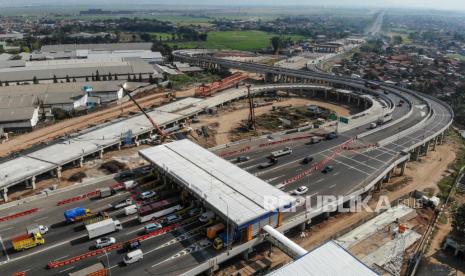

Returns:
216,141,457,276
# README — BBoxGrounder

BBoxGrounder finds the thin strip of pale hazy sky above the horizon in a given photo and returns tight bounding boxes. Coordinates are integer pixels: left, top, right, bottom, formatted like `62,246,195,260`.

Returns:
0,0,465,11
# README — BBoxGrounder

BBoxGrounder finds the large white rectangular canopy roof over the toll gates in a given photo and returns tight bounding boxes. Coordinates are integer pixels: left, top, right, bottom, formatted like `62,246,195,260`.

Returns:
139,139,295,227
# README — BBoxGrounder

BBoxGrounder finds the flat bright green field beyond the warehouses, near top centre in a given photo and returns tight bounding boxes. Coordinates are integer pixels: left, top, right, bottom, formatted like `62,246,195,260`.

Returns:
172,31,304,51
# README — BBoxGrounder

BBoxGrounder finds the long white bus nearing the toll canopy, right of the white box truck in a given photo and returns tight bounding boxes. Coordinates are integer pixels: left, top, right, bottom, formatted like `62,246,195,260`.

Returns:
137,197,183,223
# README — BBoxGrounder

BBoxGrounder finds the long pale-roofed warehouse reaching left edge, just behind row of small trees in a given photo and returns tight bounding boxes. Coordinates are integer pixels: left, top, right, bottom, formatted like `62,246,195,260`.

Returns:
0,58,154,85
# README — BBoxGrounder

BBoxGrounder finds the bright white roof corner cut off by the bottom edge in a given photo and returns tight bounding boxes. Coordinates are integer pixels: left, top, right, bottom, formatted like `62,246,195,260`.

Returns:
268,241,379,276
